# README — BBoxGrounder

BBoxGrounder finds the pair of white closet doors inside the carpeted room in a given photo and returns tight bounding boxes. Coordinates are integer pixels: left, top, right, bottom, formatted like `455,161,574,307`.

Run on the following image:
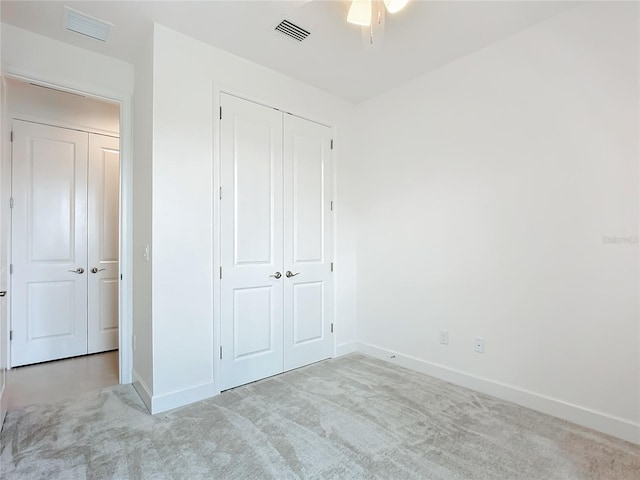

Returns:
219,94,333,390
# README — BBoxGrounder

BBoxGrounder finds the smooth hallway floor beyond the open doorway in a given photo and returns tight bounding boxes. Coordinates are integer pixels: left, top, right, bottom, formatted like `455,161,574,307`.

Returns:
5,350,118,410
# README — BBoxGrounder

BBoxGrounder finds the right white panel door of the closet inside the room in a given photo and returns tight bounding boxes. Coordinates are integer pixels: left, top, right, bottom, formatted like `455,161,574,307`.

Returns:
284,115,333,370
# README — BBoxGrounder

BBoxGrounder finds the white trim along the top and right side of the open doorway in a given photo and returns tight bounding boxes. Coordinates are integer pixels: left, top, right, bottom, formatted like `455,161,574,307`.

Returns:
2,69,133,383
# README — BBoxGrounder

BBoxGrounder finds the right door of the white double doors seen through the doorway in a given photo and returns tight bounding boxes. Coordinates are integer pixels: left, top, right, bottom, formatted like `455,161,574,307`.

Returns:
87,134,120,353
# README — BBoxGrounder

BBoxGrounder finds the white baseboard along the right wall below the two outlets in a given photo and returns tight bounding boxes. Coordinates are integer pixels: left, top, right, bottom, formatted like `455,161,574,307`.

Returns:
358,342,640,444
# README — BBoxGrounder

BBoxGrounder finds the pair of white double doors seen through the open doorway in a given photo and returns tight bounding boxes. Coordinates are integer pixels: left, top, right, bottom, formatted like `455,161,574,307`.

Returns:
11,120,120,366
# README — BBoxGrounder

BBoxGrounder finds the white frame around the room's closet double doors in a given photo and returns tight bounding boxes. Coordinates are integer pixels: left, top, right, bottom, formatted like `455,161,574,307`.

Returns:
211,85,340,395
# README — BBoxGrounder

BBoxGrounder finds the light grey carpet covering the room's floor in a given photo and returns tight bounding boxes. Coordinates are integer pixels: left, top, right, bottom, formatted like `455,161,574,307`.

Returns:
0,355,640,480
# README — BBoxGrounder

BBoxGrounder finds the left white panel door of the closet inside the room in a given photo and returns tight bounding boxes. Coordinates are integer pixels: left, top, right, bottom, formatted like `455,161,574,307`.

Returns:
220,94,284,390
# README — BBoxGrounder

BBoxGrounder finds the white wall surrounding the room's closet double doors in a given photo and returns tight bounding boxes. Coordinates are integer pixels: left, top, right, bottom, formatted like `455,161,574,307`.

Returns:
153,25,355,411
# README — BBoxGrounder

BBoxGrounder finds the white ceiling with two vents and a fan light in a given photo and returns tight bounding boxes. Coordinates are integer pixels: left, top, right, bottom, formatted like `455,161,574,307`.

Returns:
0,0,576,103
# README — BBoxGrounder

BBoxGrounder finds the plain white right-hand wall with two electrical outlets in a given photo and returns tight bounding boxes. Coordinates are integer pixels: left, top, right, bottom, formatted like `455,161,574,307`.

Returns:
349,3,640,442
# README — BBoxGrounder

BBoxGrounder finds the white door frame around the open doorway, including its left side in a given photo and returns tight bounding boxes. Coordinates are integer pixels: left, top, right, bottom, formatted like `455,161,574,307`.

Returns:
0,68,133,383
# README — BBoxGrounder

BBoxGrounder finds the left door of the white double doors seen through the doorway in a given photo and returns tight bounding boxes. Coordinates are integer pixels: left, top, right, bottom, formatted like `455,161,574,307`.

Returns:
11,121,88,366
